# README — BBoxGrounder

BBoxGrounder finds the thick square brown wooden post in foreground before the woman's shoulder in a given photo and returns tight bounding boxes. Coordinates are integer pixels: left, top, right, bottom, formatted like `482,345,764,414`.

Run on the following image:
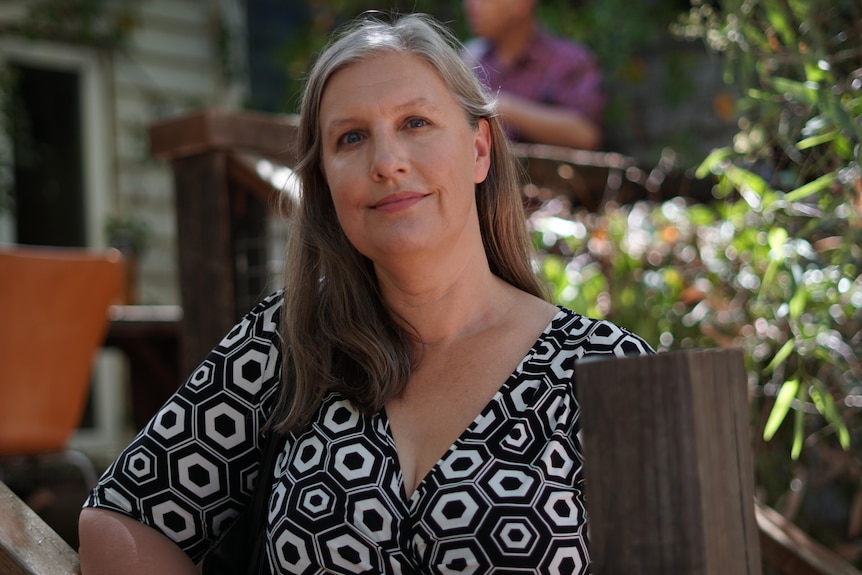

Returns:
575,349,761,575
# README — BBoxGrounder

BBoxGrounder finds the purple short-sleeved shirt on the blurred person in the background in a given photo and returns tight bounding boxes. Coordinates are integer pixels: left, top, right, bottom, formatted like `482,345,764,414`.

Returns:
466,33,605,143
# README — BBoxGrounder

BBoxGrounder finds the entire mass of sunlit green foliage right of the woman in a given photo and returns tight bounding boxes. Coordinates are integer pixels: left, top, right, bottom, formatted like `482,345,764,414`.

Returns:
530,0,862,552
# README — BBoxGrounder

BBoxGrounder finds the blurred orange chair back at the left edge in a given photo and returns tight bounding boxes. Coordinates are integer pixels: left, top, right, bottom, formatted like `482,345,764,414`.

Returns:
0,246,125,486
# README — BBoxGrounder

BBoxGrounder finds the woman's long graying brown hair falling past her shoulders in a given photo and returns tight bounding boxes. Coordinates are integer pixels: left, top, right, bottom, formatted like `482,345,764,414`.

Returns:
271,14,543,431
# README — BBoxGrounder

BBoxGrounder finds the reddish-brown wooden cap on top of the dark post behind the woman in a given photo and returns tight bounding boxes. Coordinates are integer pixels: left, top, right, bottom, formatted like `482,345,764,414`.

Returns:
149,109,297,167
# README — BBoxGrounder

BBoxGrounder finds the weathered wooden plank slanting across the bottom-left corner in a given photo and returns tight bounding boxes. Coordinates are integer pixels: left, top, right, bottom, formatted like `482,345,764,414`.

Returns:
0,481,81,575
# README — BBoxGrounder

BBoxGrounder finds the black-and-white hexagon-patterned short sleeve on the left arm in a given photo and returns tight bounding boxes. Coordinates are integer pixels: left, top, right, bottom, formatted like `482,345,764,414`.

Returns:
84,293,283,560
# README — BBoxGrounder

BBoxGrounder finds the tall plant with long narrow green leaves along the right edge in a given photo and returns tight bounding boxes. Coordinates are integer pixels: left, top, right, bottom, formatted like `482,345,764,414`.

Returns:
688,0,862,457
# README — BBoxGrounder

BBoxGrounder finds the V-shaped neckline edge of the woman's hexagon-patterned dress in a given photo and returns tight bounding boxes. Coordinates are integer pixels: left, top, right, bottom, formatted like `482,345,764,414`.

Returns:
378,306,566,509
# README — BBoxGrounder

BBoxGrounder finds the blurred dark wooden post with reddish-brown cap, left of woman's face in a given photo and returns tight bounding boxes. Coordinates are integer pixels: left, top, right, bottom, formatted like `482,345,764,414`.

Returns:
149,109,296,378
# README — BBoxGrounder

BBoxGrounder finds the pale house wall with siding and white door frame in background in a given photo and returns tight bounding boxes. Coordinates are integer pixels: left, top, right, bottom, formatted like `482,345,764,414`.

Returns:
0,0,245,304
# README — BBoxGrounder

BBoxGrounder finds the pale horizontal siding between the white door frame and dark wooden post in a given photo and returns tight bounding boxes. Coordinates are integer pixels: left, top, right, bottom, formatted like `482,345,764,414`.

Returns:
112,0,243,304
